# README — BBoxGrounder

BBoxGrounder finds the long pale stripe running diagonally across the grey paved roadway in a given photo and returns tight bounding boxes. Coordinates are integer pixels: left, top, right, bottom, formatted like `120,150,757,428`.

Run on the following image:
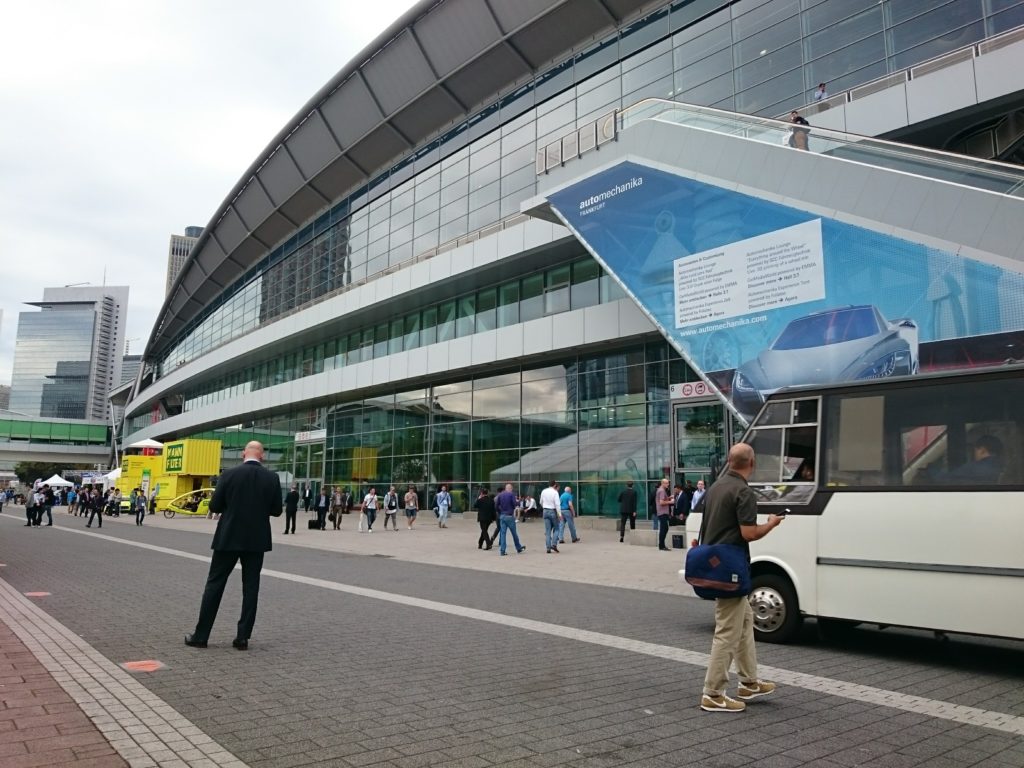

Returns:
4,515,1024,735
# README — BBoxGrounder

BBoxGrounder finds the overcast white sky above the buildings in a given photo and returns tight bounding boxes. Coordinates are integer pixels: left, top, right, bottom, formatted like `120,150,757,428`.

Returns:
0,0,413,384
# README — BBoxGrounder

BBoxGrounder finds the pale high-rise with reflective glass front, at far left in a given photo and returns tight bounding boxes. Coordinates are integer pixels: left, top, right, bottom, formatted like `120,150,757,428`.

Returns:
10,286,128,419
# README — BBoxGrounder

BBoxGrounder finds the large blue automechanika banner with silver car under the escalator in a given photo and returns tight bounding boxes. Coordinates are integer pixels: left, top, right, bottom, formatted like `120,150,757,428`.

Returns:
549,162,1024,417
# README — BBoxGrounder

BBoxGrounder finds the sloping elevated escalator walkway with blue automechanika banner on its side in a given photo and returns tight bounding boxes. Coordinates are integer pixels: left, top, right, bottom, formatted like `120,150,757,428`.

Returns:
526,100,1024,418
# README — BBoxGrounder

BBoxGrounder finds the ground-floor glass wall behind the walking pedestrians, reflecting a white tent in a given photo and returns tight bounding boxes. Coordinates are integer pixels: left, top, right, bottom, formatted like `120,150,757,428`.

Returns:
182,340,694,515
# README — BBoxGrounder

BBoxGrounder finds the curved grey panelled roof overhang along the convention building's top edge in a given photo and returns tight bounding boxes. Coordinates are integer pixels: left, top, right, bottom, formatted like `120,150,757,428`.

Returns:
145,0,665,358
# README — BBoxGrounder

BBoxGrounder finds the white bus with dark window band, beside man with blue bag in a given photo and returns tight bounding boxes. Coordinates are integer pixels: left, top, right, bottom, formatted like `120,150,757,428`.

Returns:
688,365,1024,642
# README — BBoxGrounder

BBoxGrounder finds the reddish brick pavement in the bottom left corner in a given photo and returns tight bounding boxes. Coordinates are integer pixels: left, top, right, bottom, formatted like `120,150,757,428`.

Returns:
0,622,128,768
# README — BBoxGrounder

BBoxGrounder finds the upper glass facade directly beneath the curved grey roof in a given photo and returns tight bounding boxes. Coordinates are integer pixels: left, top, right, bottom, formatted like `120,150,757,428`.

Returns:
148,0,1024,376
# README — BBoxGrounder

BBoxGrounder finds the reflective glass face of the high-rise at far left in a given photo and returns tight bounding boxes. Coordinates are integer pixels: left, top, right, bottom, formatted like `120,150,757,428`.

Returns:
10,303,96,419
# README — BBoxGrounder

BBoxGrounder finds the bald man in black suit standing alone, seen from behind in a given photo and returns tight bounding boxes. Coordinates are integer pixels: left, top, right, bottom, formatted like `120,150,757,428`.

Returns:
185,440,281,650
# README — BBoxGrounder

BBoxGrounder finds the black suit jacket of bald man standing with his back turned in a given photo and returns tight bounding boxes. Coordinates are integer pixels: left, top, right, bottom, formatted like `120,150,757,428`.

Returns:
210,462,281,552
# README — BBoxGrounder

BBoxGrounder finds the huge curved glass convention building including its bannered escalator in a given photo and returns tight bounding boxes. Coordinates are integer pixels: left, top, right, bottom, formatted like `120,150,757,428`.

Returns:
122,0,1024,515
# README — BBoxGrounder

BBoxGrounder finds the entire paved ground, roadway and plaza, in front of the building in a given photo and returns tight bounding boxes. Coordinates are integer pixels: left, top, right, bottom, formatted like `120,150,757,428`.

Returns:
0,507,1024,768
